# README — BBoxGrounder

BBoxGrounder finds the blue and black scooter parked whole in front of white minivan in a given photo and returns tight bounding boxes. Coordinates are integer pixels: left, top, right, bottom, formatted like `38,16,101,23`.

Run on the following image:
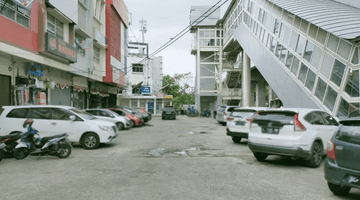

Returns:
14,119,72,160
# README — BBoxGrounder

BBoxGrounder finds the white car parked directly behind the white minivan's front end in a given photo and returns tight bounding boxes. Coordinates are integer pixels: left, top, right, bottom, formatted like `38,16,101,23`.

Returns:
85,108,131,130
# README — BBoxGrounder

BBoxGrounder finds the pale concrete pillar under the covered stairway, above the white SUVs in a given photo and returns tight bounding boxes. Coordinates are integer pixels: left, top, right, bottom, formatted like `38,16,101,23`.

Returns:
242,51,251,107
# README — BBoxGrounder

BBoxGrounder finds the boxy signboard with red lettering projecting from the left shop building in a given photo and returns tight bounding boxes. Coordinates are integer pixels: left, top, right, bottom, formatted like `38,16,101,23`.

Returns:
45,32,77,63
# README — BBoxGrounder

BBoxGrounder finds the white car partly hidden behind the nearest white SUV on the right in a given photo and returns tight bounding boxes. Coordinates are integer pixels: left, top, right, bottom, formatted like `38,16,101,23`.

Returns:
226,107,267,143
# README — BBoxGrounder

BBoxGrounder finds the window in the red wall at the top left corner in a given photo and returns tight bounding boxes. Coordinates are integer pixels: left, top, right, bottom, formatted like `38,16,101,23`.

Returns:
0,0,30,28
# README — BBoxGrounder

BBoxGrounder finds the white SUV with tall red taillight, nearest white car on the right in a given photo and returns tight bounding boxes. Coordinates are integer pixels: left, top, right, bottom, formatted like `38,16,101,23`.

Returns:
248,108,339,168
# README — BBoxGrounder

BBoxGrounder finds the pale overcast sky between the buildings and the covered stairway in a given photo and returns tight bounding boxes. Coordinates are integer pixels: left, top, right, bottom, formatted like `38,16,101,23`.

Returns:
124,0,231,79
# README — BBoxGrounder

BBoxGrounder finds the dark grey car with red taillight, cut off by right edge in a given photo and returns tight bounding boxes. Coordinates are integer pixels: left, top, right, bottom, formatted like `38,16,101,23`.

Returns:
325,118,360,195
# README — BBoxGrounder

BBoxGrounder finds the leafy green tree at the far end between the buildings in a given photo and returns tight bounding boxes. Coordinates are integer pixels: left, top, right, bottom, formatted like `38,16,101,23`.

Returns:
163,72,195,107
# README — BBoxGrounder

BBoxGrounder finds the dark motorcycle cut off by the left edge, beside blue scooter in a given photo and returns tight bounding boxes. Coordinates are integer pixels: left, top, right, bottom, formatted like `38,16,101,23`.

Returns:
0,132,24,161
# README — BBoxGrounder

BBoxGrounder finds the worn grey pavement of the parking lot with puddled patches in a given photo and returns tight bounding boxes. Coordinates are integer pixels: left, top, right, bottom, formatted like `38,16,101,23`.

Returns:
0,116,360,200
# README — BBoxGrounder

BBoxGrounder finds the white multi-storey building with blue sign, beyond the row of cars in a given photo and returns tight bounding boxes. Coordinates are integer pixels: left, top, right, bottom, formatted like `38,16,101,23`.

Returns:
118,42,168,114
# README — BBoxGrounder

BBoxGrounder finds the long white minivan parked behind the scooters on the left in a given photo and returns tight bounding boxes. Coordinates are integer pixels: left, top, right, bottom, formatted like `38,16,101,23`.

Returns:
0,105,118,149
